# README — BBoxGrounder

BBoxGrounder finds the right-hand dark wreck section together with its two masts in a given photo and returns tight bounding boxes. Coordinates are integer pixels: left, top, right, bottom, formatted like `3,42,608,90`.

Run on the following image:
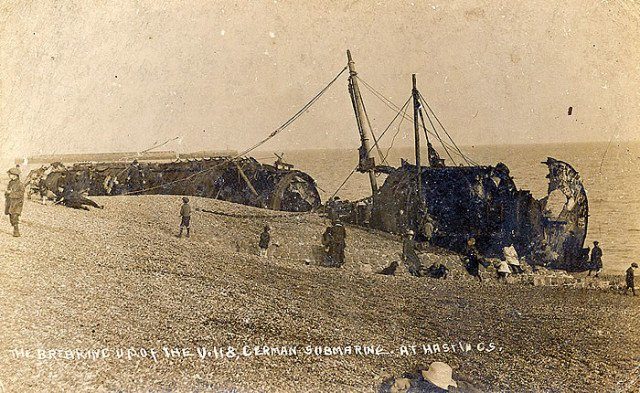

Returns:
330,52,589,271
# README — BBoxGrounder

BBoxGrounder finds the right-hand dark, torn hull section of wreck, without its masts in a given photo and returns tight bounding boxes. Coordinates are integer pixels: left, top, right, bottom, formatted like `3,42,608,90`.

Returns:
370,158,588,271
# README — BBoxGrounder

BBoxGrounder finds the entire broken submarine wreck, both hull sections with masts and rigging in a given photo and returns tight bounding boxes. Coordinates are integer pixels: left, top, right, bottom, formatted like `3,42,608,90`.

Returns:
21,51,589,271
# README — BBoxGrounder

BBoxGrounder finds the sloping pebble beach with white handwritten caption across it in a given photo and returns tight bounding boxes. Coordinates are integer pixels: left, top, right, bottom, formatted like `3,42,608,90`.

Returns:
0,196,640,392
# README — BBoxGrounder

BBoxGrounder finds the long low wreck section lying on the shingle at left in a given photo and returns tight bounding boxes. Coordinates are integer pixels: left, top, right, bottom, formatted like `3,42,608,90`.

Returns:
30,157,320,212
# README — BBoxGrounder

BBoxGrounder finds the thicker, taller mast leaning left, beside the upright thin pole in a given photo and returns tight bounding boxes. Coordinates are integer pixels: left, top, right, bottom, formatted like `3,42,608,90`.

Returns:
347,50,378,194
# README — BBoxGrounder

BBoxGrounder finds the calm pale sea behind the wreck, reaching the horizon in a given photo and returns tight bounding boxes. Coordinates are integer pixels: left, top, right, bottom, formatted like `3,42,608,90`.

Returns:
270,141,640,274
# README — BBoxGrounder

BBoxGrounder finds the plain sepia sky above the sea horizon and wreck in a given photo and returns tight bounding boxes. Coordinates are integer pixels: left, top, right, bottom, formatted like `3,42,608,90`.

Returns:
0,0,640,160
